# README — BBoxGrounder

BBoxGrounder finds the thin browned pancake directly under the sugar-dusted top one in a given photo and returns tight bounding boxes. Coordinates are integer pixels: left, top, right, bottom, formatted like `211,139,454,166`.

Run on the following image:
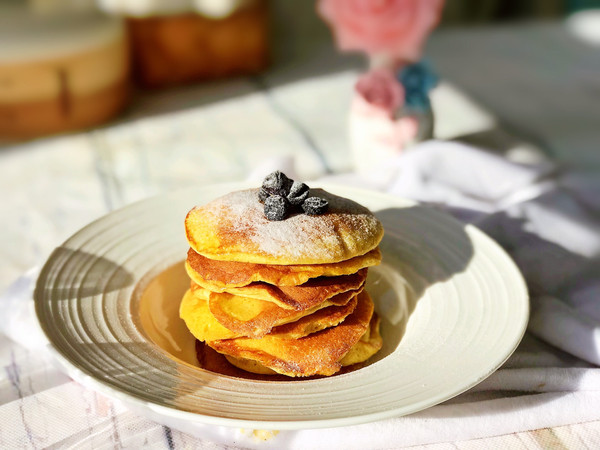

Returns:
185,248,381,292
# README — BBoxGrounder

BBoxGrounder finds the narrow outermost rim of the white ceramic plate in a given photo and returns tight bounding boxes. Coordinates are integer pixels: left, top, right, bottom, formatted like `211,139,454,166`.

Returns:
33,182,530,430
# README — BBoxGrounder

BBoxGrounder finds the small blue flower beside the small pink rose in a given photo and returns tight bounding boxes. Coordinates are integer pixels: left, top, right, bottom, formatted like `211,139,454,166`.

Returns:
397,60,439,112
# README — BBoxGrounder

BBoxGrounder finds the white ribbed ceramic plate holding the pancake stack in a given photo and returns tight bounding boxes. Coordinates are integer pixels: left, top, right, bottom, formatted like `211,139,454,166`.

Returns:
35,184,529,430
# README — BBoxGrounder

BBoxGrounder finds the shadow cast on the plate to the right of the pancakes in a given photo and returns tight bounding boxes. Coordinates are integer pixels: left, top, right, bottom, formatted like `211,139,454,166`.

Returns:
367,205,473,363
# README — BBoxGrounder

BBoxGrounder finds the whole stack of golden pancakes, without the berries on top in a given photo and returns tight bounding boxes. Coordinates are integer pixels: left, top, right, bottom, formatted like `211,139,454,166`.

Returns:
180,189,383,377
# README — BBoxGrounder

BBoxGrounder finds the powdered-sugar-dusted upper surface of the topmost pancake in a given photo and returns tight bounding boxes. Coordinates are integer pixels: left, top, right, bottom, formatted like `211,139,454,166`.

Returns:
200,189,382,261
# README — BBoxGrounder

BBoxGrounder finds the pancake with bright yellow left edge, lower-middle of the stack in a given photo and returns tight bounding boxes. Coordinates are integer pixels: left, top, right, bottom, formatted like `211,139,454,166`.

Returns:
179,287,357,341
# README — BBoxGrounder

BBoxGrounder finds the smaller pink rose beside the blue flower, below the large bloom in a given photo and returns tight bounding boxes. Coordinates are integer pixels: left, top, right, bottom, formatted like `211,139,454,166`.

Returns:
354,69,404,118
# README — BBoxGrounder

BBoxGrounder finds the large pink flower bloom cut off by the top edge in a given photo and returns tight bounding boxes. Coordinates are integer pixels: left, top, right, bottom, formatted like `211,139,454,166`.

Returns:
317,0,444,61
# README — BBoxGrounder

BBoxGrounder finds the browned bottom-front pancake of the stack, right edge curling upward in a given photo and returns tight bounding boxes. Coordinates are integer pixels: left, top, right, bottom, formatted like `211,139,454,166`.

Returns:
208,291,373,377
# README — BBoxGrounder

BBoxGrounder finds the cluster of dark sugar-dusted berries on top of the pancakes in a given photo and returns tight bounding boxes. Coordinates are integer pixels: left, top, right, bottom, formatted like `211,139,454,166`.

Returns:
258,171,329,220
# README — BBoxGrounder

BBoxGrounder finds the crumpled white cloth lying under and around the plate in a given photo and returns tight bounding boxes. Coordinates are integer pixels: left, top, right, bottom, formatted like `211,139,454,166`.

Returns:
0,141,600,449
